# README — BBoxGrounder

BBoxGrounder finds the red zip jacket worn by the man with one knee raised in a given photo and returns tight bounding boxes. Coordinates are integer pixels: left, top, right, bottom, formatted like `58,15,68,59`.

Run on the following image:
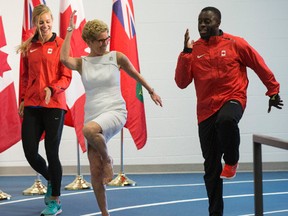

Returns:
175,33,280,123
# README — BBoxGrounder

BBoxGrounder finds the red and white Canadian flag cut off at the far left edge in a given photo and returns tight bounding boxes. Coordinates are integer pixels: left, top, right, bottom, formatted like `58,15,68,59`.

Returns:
0,16,21,153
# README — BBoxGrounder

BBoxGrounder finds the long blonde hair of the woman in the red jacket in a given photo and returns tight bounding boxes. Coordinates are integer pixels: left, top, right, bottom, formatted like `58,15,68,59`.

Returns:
17,4,53,56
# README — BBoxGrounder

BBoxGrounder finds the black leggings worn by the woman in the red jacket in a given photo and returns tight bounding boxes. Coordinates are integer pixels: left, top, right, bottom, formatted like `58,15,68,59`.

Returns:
22,107,65,196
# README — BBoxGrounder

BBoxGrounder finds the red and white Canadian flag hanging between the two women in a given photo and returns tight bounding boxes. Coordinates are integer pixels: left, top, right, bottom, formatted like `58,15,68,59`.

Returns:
60,0,87,152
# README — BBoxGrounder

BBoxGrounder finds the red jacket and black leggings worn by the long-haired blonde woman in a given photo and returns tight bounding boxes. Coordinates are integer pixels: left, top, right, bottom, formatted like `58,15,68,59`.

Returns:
20,33,72,201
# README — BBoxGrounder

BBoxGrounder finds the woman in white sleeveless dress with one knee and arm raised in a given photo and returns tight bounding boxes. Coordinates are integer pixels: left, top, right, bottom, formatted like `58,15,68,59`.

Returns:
60,11,162,216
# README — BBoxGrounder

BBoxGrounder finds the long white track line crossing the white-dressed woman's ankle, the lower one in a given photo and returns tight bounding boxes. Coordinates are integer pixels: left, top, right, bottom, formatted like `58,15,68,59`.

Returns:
80,191,288,216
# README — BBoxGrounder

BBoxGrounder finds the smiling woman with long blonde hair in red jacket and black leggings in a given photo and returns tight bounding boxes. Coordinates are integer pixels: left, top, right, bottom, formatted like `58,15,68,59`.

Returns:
17,5,72,216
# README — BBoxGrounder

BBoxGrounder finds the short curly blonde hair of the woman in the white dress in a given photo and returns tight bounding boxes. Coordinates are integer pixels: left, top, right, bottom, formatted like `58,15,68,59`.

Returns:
82,19,109,43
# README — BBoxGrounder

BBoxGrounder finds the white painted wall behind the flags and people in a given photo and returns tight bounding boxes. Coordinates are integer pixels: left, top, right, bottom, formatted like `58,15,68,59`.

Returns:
0,0,288,167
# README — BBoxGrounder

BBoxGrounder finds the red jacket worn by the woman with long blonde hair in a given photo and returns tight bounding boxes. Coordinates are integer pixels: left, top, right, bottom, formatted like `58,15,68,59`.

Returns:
20,33,72,110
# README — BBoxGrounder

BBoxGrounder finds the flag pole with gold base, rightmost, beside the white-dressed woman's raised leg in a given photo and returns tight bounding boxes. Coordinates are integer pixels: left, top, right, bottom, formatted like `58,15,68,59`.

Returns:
108,129,136,187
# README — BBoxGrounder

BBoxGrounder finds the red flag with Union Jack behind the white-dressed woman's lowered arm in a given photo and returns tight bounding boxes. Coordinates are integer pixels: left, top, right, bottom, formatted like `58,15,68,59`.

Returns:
110,0,147,150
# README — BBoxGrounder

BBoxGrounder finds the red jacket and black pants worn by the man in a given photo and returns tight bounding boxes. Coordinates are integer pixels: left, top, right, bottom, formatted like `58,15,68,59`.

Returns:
175,30,279,216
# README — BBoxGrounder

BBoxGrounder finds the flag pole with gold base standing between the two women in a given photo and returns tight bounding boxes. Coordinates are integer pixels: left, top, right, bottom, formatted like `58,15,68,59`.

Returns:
65,140,91,190
